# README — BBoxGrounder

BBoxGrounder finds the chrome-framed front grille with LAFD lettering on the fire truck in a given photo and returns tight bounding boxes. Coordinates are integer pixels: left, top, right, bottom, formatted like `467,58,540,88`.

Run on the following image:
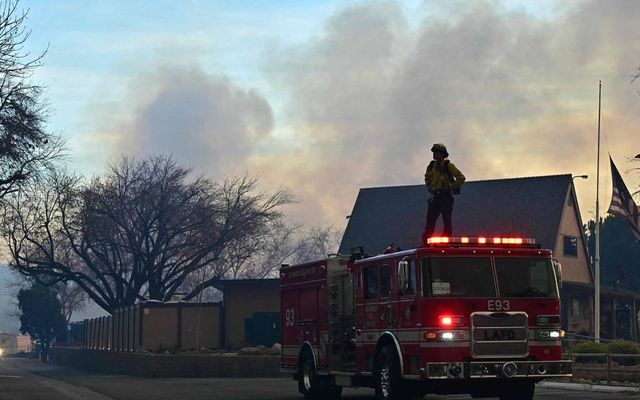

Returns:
471,312,529,358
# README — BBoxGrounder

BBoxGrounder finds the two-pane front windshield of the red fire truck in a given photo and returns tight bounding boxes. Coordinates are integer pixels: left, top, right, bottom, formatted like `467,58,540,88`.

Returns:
420,257,558,298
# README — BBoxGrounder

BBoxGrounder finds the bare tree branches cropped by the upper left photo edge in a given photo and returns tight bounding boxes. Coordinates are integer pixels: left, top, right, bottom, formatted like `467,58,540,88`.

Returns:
0,1,63,199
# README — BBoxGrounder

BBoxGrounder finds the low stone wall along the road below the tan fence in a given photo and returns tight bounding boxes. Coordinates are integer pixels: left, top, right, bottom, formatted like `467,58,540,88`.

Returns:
52,347,281,378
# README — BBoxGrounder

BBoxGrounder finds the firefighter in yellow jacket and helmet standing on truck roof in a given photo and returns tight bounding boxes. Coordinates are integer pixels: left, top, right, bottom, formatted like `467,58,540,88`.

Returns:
423,143,466,243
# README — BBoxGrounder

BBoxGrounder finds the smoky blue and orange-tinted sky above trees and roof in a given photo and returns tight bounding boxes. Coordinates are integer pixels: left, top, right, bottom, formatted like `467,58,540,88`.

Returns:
17,0,640,228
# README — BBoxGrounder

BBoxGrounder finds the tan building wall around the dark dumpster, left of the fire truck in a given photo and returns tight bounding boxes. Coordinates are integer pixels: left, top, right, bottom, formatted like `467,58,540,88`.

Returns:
224,280,280,349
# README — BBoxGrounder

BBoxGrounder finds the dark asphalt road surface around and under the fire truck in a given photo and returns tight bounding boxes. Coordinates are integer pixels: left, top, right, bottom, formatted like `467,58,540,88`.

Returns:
0,359,640,400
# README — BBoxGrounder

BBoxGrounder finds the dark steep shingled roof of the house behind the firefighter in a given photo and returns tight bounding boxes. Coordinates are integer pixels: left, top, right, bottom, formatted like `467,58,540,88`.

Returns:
339,174,572,255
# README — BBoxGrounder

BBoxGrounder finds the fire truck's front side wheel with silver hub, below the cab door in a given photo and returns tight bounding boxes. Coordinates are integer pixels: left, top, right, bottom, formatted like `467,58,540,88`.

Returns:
374,346,407,400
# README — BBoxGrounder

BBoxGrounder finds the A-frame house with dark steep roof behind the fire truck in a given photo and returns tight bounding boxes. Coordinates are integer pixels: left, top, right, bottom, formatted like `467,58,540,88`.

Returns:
339,174,639,339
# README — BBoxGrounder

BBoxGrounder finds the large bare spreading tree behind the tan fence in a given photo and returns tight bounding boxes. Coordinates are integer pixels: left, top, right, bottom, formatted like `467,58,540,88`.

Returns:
3,157,292,312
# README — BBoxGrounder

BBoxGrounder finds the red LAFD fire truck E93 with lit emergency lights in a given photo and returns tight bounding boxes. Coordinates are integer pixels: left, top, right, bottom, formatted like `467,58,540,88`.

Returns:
280,237,572,400
